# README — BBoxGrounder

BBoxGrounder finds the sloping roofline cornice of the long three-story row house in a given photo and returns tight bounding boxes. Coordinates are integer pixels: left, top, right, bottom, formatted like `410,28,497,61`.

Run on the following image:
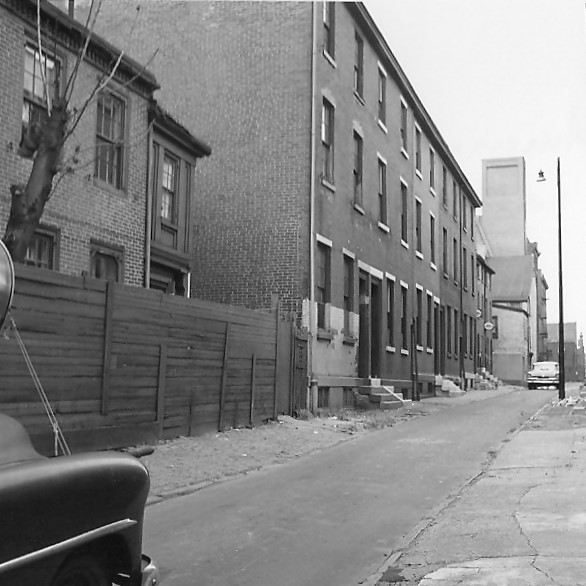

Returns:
344,2,482,208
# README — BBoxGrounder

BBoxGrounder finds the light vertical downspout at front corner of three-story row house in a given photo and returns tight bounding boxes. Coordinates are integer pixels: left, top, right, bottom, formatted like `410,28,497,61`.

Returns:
307,2,317,411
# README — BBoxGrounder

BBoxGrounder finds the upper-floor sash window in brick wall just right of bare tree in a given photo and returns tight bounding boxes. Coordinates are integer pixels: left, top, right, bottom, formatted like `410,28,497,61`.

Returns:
94,92,125,189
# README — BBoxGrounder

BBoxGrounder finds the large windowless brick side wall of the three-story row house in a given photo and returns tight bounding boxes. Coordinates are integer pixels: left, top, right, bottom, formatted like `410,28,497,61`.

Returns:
88,0,312,312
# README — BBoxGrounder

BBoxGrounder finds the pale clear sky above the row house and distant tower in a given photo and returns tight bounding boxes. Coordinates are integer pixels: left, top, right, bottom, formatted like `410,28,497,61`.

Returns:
364,0,586,336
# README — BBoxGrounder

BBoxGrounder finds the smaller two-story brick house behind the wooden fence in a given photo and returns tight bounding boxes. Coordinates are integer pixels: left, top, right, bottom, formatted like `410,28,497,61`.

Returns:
0,0,210,293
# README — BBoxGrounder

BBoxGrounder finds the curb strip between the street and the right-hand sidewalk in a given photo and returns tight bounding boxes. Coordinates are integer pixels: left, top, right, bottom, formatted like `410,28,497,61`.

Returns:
358,392,551,586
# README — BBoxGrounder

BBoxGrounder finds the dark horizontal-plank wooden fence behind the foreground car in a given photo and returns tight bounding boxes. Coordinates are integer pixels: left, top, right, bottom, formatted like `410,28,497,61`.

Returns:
0,266,289,453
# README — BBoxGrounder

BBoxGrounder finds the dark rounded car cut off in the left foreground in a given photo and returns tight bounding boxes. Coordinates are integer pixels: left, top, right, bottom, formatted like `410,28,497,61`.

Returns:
0,242,159,586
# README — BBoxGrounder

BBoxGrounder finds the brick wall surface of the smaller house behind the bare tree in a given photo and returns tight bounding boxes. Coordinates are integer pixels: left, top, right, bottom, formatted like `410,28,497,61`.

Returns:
0,6,148,285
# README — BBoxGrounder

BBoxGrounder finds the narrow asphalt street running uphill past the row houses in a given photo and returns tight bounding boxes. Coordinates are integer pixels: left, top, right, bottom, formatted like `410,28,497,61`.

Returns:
144,390,555,586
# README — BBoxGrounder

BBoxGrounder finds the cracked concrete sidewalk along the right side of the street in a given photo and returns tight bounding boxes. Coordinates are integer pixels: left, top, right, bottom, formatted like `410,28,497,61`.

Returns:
366,391,586,586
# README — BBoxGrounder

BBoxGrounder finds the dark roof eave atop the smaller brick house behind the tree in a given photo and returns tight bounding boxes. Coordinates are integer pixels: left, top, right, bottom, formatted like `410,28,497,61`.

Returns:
5,0,161,92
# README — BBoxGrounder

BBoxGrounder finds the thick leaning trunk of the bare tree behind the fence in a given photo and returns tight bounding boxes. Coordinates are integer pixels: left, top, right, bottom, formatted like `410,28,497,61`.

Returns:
3,101,67,262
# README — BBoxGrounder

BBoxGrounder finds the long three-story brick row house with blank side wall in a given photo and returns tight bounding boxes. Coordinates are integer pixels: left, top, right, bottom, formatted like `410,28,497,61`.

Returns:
91,0,481,407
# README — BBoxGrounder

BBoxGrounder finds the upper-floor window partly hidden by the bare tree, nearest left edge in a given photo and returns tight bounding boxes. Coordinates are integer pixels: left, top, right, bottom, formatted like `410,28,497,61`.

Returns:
22,43,61,137
